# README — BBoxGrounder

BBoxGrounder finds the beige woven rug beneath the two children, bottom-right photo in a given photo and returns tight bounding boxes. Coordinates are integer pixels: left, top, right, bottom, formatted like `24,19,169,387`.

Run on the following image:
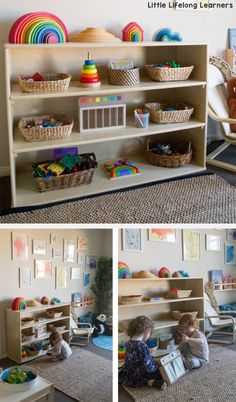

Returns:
124,345,236,402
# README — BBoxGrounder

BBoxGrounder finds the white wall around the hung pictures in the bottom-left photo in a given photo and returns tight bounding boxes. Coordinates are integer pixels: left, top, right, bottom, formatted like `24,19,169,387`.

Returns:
0,228,112,358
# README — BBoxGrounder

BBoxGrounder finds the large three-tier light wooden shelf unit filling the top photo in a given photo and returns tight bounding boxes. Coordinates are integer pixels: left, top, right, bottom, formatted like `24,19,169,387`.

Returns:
5,42,208,207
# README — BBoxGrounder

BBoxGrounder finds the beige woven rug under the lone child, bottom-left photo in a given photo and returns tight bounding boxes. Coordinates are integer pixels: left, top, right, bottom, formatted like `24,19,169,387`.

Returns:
29,347,112,402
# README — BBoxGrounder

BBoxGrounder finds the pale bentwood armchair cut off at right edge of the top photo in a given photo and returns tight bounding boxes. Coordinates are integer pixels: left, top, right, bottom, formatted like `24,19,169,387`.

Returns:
206,57,236,172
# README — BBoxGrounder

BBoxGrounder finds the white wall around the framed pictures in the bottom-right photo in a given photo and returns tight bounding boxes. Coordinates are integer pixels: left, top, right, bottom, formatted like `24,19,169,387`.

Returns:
119,229,236,304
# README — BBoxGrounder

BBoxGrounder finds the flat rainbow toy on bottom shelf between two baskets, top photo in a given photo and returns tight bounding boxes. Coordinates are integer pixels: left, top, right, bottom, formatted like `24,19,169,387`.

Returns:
102,159,140,179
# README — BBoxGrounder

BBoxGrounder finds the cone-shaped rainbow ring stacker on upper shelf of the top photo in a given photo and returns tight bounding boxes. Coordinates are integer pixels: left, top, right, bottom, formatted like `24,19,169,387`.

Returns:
79,53,101,88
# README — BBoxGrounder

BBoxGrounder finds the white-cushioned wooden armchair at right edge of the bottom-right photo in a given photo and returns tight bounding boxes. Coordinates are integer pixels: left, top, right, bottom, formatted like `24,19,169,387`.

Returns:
204,293,236,345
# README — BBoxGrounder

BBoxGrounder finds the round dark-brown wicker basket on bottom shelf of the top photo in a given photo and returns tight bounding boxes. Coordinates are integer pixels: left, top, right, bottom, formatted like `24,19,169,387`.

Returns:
147,140,192,168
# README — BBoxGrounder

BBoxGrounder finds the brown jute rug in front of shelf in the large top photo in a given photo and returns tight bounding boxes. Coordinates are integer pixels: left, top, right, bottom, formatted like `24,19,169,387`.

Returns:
0,175,236,223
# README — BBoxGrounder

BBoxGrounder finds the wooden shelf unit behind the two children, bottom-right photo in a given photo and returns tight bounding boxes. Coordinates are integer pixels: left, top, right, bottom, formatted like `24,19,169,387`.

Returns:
118,277,204,337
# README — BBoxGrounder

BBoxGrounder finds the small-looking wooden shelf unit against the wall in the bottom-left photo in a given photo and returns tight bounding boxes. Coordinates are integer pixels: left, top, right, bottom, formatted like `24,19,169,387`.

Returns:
6,303,71,363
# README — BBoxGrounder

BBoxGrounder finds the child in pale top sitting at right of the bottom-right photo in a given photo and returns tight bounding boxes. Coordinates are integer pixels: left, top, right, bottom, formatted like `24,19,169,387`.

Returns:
178,314,209,370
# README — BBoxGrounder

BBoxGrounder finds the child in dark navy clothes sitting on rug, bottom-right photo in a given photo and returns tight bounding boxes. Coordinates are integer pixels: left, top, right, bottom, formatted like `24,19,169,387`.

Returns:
119,316,166,390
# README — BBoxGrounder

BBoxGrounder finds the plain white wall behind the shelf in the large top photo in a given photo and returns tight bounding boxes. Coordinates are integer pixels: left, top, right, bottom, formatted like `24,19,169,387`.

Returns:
0,0,236,173
